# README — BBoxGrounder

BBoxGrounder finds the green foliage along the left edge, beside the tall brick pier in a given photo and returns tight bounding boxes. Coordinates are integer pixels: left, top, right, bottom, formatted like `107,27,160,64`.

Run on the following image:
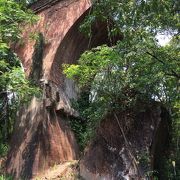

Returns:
0,0,40,156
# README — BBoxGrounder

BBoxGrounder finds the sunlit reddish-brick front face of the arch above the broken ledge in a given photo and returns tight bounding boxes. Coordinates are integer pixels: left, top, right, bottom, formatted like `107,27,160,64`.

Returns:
16,0,91,81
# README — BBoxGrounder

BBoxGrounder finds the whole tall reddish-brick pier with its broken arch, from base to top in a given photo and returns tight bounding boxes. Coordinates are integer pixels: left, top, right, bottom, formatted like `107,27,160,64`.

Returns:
6,0,119,179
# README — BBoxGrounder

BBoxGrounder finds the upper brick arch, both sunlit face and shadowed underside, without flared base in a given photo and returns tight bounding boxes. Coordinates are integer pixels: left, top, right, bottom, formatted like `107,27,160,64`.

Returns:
16,0,121,90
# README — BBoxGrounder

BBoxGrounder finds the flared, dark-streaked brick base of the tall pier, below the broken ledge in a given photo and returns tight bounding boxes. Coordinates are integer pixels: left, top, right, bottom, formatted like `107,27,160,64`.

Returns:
6,98,78,179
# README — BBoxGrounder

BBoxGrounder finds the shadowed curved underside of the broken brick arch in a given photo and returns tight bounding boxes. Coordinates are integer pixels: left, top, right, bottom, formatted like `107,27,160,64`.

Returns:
50,8,122,99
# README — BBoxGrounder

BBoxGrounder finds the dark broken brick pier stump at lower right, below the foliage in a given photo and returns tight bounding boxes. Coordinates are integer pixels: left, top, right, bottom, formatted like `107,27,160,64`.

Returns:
80,104,168,180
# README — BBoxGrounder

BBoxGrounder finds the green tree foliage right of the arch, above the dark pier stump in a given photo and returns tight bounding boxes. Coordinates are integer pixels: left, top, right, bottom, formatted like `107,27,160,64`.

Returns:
64,0,180,179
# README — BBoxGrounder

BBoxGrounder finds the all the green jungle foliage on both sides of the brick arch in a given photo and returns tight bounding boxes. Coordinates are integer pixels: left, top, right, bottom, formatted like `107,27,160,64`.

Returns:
0,0,180,179
